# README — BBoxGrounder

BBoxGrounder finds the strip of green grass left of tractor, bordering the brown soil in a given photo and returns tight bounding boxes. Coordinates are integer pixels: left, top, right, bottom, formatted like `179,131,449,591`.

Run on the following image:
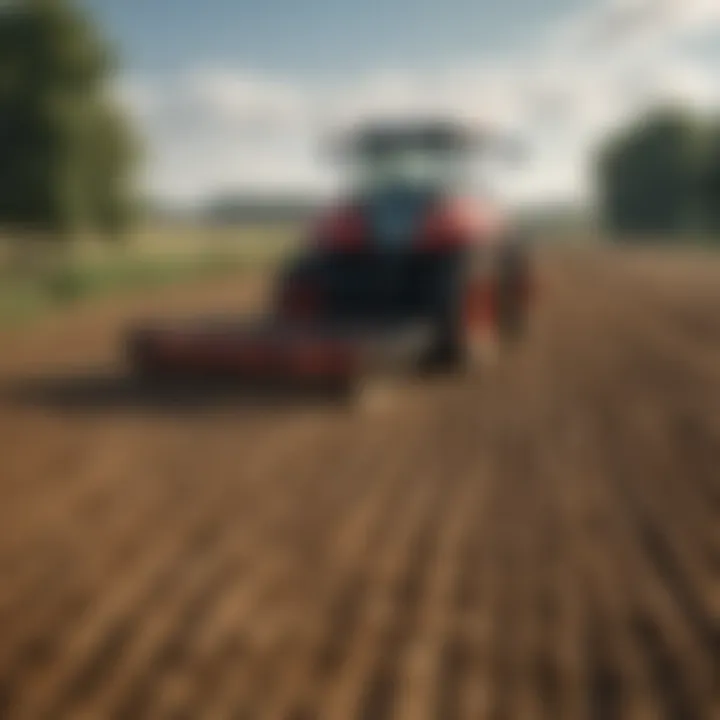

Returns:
0,228,296,326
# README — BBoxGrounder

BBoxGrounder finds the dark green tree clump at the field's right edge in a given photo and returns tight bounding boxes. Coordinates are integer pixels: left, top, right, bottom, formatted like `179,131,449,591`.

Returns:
598,108,720,240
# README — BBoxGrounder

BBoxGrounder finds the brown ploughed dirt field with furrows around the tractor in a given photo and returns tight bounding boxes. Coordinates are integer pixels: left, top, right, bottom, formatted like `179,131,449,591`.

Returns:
0,251,720,720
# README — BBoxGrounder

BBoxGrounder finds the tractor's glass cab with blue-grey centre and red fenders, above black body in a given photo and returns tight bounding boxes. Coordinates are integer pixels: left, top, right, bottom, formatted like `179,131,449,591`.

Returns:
316,122,500,252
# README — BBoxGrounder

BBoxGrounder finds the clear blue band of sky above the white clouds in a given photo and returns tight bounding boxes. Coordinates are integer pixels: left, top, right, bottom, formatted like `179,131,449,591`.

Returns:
85,0,587,76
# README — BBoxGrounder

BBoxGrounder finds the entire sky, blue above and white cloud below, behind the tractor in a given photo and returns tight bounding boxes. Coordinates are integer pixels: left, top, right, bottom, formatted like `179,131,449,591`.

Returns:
82,0,720,203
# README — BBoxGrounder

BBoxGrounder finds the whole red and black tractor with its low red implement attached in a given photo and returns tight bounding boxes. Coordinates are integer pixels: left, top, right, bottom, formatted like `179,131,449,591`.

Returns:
129,122,531,396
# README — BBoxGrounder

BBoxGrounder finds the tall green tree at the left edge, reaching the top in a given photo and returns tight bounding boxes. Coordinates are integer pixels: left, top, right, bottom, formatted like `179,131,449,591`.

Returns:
0,0,135,234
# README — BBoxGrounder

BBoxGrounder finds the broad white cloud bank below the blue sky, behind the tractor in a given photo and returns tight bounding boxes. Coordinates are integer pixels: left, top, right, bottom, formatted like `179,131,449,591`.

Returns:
119,0,720,208
